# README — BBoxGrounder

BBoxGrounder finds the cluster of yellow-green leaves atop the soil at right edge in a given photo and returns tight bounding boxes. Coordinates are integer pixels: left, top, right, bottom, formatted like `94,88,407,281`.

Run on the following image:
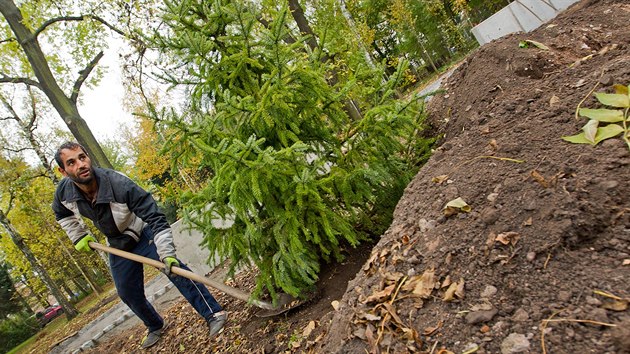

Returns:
562,85,630,149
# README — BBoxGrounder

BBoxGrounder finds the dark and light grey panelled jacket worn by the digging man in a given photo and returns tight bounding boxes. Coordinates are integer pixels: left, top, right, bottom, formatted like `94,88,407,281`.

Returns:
52,167,175,259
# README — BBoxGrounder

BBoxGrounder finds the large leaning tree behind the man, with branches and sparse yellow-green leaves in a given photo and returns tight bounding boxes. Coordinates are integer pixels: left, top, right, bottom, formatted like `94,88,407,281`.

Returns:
0,0,156,168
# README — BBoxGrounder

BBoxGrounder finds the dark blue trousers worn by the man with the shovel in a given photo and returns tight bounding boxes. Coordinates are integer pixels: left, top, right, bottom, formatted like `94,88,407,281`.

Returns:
109,226,222,332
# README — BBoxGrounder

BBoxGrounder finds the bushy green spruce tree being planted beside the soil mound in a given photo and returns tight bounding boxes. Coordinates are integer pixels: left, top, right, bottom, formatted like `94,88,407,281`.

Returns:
157,1,429,296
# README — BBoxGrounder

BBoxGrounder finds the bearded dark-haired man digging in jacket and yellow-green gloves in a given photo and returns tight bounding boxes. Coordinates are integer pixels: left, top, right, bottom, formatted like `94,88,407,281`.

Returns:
52,142,227,348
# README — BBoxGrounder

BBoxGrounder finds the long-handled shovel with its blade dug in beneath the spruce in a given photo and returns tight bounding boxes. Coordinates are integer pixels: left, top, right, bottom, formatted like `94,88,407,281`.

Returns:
88,242,303,317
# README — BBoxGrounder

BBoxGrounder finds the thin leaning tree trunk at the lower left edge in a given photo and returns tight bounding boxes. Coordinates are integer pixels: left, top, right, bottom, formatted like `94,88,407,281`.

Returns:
0,210,79,320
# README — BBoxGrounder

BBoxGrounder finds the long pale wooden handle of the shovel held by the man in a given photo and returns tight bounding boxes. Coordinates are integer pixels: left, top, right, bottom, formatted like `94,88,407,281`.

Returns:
88,242,276,310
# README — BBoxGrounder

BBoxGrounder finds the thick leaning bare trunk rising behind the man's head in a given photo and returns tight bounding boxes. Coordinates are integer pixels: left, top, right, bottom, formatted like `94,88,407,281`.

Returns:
0,0,112,168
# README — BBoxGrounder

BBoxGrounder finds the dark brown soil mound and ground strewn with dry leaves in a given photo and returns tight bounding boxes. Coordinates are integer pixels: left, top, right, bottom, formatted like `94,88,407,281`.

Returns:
86,0,630,354
